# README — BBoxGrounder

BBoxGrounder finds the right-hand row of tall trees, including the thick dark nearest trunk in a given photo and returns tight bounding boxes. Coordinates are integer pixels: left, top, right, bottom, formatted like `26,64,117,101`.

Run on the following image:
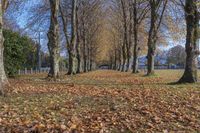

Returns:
107,0,199,83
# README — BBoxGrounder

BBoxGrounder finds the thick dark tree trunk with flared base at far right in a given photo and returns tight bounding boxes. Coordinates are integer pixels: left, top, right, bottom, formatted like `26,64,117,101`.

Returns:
178,0,199,83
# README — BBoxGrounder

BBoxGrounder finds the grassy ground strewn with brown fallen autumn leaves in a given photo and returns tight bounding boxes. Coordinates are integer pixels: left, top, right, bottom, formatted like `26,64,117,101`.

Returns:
0,70,200,133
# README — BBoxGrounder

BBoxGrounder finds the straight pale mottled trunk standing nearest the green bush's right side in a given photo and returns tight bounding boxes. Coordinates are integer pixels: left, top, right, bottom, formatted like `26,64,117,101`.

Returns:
47,0,60,79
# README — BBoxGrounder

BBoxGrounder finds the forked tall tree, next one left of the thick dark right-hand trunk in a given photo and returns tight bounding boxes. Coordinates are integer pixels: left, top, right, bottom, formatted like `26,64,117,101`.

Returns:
147,0,168,75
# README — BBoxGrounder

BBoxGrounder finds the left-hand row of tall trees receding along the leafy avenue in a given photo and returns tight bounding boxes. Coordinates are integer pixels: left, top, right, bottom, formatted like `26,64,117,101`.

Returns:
48,0,101,79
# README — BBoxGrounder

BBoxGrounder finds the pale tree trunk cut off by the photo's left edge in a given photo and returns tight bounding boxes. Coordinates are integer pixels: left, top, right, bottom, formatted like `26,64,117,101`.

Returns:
0,0,8,95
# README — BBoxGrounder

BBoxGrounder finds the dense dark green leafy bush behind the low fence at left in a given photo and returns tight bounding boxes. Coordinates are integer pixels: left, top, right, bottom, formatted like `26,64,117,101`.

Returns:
3,29,36,76
